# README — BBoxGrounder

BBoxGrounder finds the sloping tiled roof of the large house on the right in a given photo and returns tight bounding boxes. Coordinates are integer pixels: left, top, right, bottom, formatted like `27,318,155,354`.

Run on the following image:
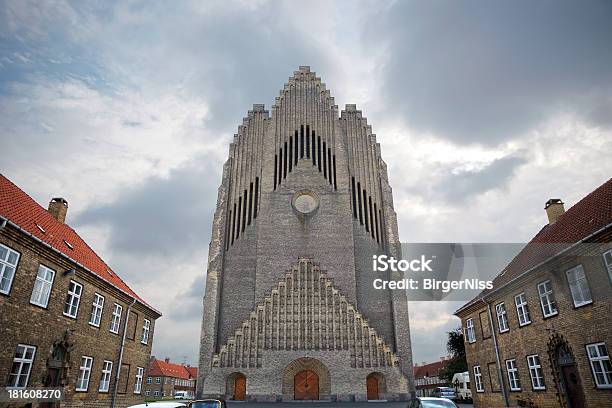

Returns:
455,178,612,314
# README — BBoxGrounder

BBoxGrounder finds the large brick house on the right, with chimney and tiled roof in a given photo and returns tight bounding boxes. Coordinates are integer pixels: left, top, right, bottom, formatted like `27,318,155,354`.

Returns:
456,179,612,408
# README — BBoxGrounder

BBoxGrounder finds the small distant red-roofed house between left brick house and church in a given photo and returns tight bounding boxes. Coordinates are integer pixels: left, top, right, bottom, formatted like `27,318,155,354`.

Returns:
144,357,198,399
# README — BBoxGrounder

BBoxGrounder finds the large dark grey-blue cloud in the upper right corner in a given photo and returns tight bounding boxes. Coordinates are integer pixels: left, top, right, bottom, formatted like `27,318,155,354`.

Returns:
366,1,612,144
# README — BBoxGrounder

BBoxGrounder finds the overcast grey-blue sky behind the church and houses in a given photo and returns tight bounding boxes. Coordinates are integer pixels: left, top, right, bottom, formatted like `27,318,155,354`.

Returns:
0,0,612,363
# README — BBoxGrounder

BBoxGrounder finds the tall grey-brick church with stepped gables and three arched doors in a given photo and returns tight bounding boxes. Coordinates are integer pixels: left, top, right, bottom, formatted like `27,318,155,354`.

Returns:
198,66,414,401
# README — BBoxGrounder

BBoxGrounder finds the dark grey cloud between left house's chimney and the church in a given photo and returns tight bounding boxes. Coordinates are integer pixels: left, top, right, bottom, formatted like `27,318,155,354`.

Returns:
75,157,221,258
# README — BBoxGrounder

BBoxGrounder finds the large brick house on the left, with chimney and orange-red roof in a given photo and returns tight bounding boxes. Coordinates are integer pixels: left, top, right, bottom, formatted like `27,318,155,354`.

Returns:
0,175,161,407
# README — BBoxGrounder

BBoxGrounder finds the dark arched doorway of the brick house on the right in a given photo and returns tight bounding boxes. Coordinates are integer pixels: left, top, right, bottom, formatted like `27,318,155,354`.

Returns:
548,334,585,408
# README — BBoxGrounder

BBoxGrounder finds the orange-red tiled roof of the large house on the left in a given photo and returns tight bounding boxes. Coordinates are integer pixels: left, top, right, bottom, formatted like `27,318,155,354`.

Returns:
0,174,159,313
